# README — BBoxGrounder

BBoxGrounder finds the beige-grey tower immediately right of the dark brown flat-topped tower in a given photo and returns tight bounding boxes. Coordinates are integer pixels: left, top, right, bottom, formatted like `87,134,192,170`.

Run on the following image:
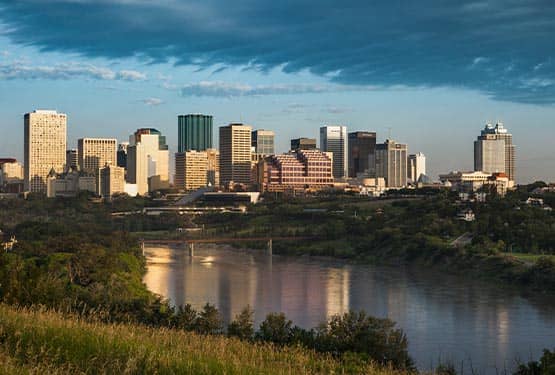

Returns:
376,139,408,188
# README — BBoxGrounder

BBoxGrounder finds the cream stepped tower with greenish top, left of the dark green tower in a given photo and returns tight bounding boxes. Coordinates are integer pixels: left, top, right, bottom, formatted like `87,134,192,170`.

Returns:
127,128,169,195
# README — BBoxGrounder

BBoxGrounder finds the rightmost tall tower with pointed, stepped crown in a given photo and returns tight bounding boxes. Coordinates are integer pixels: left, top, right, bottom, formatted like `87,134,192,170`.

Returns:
474,122,515,181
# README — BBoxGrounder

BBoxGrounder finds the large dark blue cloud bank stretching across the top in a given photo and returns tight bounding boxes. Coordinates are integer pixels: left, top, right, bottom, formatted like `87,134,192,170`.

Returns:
0,0,555,103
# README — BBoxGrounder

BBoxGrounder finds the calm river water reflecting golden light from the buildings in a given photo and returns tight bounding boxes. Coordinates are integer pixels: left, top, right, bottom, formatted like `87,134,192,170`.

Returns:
144,245,555,374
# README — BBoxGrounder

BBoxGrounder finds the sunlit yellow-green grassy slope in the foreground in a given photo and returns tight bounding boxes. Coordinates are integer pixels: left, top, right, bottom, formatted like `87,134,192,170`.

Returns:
0,305,400,375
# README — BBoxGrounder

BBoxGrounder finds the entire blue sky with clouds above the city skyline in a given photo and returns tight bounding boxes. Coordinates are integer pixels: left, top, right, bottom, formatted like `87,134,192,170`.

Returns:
0,0,555,183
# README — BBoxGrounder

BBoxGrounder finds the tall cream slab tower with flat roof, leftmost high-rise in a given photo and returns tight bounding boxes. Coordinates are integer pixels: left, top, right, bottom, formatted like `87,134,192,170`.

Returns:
24,110,67,193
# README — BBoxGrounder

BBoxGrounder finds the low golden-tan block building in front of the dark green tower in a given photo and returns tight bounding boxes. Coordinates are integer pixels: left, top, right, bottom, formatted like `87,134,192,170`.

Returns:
174,149,219,191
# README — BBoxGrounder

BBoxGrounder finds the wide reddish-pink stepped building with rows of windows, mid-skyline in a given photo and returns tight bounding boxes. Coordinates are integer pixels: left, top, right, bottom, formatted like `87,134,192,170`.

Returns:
258,150,333,192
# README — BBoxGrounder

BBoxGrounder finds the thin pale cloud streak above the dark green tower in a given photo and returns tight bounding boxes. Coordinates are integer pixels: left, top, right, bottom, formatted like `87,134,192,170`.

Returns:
180,81,346,97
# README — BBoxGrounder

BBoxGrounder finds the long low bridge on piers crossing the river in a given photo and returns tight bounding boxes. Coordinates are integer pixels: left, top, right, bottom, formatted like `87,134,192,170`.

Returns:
140,236,313,256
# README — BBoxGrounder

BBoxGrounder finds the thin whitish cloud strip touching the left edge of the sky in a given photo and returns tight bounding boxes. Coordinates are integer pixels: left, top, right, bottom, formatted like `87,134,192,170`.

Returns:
0,61,146,81
